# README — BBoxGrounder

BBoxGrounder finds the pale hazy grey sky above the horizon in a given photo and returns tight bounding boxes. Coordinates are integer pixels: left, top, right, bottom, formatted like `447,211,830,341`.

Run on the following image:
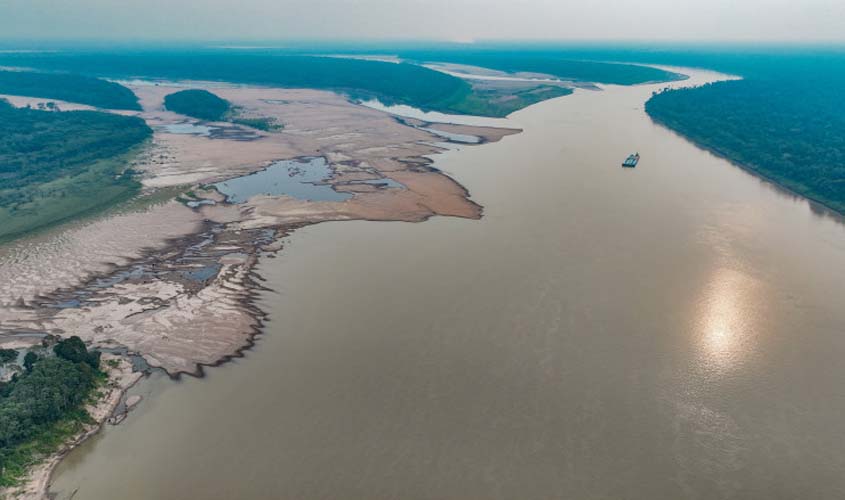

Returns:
0,0,845,41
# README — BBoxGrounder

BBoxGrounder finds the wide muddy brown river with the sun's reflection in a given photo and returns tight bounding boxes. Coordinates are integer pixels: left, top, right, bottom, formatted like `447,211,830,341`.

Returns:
54,69,845,500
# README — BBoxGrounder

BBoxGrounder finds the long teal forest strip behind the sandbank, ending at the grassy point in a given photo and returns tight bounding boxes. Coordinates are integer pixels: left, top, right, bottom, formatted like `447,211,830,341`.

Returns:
0,50,471,111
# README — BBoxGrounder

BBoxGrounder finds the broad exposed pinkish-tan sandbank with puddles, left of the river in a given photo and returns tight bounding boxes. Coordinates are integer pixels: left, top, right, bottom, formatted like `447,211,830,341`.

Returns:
0,83,517,375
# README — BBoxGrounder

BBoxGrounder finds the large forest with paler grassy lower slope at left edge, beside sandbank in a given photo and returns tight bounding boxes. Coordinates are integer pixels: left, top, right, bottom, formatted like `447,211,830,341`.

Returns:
0,100,152,239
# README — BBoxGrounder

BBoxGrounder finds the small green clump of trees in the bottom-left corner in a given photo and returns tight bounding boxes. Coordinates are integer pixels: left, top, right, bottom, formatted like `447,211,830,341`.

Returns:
0,337,104,486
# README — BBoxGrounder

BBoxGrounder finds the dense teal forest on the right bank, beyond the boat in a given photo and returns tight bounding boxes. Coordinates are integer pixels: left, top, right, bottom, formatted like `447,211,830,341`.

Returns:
646,78,845,213
